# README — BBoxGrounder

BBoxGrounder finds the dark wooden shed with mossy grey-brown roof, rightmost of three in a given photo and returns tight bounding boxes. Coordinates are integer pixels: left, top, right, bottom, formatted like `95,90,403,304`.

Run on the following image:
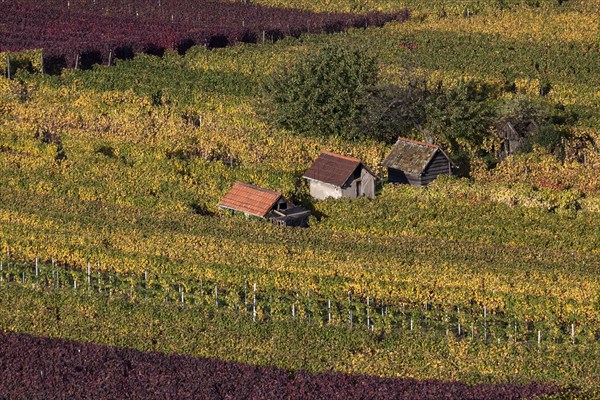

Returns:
383,138,453,186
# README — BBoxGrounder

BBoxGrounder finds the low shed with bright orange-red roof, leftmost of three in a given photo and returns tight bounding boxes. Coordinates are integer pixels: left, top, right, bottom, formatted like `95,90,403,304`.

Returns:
219,182,310,227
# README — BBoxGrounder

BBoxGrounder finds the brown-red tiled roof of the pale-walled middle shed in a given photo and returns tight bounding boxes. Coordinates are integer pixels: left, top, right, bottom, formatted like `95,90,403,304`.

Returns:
304,151,362,186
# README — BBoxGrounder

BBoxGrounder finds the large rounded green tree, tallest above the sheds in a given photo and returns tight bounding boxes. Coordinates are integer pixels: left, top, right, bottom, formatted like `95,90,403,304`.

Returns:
259,45,378,139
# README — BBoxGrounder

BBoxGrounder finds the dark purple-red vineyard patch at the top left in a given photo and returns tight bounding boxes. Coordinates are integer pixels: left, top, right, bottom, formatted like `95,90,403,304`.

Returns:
0,0,408,71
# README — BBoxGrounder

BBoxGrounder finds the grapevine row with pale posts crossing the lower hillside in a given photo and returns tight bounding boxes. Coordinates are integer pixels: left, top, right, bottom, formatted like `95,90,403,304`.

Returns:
0,259,600,344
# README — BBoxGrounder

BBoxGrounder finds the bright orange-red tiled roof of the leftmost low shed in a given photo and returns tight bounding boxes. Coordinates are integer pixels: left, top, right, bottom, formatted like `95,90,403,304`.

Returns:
219,182,281,218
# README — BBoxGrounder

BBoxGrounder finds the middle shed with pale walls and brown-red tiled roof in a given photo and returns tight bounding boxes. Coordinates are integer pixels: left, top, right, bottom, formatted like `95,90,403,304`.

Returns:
303,151,377,200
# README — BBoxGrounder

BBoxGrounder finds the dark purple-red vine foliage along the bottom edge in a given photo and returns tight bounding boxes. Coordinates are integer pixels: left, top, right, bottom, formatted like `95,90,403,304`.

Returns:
0,334,557,400
